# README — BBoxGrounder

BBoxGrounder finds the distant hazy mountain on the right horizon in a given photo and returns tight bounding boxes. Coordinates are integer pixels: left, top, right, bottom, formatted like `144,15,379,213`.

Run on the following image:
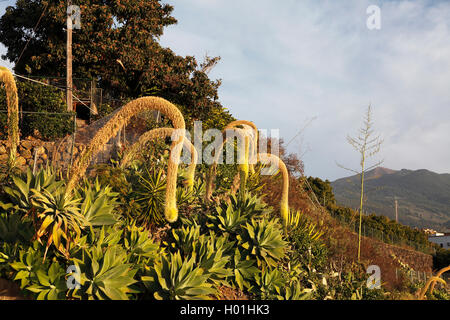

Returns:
331,167,450,232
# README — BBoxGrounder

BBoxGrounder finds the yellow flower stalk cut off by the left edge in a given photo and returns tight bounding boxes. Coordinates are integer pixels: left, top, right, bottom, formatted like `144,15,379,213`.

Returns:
0,67,19,168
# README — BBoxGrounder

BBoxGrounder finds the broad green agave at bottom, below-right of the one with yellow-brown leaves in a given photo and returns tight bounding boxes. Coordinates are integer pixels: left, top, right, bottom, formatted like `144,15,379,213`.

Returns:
70,245,137,300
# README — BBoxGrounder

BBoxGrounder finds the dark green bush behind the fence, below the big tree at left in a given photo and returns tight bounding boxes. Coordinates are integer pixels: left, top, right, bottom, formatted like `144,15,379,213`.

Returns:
0,80,74,140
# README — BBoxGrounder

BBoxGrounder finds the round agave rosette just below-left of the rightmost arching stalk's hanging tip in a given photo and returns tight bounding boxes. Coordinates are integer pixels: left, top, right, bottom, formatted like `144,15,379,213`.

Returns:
237,219,287,267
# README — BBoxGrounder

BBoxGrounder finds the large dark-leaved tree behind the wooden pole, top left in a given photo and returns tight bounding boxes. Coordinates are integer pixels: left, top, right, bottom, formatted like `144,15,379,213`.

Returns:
0,0,223,121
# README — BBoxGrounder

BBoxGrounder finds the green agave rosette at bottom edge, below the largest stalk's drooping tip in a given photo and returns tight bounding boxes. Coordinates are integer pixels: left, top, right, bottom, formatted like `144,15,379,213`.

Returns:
142,251,216,300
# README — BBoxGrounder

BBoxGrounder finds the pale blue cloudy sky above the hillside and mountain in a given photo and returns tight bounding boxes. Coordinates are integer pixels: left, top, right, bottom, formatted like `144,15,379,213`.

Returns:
0,0,450,180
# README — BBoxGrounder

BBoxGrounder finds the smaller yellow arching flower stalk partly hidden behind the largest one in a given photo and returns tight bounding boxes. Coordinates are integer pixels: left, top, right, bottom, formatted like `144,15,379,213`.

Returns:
120,128,198,190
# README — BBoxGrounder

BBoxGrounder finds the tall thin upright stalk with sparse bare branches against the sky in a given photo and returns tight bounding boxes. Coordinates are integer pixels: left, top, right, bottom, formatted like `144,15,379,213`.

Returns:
338,105,383,262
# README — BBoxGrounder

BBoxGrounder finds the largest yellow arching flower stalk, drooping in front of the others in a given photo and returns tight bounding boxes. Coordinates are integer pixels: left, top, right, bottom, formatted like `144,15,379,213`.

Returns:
66,97,186,223
